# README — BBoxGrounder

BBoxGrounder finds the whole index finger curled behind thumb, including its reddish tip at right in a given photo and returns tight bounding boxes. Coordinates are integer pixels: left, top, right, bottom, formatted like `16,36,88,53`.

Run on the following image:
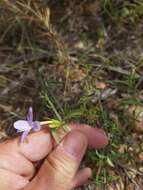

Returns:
1,124,108,162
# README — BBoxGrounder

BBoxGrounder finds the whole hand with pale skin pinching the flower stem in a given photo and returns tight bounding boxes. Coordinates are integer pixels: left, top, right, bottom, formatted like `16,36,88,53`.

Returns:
0,124,108,190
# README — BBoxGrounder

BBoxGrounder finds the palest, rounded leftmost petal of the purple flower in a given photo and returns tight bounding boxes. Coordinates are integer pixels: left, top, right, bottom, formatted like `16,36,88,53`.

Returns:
14,120,32,132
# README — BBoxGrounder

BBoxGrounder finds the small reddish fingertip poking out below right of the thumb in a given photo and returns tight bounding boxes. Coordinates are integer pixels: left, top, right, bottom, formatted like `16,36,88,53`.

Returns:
73,168,92,188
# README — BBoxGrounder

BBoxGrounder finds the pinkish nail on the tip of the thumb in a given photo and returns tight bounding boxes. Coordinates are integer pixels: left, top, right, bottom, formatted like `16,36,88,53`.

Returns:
62,131,87,158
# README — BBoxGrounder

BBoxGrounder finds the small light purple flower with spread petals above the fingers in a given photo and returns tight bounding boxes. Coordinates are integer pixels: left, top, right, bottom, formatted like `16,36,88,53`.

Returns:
14,107,41,142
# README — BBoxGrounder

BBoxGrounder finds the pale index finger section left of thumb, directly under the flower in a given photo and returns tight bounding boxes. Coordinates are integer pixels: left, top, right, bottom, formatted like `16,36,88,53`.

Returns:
0,130,52,162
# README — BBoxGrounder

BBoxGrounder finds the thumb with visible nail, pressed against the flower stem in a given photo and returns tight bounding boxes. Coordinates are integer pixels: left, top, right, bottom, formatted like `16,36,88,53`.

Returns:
25,131,87,190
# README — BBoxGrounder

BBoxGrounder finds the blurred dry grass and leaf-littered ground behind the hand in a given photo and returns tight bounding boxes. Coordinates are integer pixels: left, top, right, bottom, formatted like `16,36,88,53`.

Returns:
0,0,143,190
